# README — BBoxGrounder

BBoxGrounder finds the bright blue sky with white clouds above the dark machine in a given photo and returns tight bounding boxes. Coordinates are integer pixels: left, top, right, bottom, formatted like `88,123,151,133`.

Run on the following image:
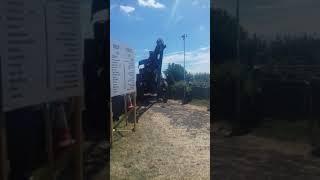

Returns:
110,0,210,73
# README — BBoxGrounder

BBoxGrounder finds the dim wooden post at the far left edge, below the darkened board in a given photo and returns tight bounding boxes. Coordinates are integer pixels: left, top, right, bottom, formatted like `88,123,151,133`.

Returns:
0,112,8,180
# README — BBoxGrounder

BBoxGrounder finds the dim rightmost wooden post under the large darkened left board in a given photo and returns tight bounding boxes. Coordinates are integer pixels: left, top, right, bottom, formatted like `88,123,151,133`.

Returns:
73,96,84,180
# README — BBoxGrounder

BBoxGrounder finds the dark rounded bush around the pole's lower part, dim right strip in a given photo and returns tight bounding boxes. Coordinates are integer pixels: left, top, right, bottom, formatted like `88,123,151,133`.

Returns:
212,63,258,120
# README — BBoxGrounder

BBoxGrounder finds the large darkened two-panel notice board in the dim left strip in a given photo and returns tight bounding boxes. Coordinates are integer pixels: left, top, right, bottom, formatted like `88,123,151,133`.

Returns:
0,0,83,111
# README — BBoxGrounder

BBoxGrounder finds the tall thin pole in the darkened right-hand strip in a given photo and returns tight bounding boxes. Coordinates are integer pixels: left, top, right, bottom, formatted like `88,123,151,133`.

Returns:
236,0,241,130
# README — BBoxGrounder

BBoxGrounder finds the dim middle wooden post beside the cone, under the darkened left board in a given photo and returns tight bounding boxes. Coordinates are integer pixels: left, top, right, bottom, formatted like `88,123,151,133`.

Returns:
43,103,55,180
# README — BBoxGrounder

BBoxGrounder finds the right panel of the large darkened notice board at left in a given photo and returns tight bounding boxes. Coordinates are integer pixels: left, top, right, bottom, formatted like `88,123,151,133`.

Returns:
46,0,83,100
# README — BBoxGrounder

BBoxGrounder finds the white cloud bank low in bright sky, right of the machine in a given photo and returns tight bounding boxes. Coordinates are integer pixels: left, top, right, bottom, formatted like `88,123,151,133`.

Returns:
162,47,210,73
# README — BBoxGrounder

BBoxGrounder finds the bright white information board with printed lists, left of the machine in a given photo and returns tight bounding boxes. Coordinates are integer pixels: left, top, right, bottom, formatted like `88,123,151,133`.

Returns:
110,41,136,97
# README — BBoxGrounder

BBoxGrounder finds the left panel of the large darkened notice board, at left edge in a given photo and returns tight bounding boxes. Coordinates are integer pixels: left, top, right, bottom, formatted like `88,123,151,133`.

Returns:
0,0,46,111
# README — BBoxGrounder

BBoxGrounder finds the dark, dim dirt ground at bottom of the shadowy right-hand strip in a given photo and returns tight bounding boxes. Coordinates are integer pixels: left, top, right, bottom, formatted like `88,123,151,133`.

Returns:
211,123,320,180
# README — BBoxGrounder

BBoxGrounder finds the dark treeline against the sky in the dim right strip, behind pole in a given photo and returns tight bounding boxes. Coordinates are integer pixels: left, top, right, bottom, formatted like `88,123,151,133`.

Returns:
211,8,320,65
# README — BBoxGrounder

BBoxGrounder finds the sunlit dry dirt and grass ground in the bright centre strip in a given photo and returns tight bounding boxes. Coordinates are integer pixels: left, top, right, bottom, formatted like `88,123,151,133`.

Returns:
111,100,210,180
